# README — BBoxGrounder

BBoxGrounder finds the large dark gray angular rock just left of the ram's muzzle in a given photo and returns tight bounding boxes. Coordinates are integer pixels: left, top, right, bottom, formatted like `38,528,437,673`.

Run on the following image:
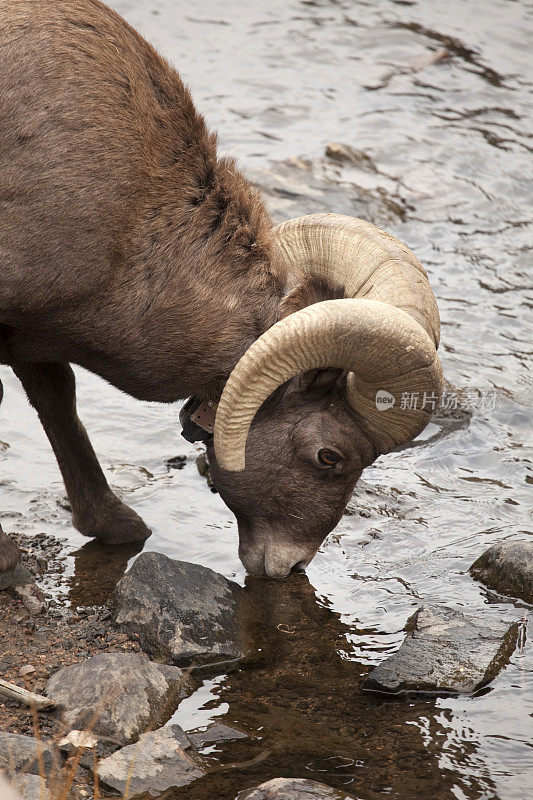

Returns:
114,553,243,665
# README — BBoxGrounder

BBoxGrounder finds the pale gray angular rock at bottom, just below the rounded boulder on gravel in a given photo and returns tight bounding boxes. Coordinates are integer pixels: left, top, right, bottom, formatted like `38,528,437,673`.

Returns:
98,725,205,797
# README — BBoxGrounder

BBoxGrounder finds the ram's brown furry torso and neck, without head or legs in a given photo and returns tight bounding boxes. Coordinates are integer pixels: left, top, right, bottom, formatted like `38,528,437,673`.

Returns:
0,0,286,401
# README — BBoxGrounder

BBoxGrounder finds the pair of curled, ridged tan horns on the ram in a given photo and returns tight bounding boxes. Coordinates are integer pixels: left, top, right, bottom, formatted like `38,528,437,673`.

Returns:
214,214,442,471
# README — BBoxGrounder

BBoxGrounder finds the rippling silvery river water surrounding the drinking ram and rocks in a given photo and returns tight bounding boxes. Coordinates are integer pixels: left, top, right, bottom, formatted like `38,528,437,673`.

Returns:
0,0,533,800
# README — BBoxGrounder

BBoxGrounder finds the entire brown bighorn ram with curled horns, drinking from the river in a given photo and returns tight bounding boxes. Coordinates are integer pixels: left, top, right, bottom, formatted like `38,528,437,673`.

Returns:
0,0,442,576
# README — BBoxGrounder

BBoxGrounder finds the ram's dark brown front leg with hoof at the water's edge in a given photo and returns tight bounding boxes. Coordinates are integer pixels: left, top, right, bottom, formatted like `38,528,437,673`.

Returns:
10,362,151,544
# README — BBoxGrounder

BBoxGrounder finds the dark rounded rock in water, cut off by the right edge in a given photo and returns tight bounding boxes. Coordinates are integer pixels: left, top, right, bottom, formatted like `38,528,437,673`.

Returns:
470,538,533,603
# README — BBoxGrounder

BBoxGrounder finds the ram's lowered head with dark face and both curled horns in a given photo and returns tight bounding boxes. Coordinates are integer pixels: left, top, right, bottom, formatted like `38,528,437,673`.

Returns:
208,214,442,577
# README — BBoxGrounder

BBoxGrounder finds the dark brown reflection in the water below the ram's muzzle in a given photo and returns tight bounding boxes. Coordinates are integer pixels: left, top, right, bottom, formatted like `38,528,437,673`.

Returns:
168,575,498,800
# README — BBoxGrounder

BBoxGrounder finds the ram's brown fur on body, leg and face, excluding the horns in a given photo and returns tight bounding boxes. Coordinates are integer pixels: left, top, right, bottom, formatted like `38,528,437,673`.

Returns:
0,0,374,574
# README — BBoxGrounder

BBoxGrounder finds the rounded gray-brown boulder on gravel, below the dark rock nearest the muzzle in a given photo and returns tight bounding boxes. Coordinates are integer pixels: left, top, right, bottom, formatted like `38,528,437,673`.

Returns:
45,653,196,745
